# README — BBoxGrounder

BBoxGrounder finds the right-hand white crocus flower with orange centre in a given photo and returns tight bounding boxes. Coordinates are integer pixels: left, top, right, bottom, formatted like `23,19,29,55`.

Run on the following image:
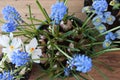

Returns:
26,38,42,63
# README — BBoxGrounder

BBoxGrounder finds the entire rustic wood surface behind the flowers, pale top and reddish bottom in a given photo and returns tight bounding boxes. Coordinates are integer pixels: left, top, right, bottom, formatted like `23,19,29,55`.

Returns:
0,0,120,80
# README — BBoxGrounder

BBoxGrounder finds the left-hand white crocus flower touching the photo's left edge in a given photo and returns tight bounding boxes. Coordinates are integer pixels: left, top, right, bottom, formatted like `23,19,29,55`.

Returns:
0,33,22,60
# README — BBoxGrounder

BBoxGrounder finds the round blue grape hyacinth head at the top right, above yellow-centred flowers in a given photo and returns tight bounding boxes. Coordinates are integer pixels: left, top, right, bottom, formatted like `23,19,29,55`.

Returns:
92,0,108,14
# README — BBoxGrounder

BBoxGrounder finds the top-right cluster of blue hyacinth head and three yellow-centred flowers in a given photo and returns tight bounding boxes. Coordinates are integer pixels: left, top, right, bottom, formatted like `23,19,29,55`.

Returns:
92,0,115,33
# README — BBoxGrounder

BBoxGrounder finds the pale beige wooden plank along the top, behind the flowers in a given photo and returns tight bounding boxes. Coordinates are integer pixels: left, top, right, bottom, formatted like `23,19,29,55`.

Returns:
0,0,85,25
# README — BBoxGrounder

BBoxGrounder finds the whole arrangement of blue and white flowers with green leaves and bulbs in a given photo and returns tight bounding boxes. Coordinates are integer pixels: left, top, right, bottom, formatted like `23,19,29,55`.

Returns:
0,0,120,80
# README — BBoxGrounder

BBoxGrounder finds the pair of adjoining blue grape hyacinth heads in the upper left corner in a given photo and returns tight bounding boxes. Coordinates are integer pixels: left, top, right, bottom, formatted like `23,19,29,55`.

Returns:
1,6,21,32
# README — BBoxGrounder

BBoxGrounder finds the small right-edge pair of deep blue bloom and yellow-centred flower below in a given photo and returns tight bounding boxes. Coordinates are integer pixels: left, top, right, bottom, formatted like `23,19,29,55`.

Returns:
103,32,117,48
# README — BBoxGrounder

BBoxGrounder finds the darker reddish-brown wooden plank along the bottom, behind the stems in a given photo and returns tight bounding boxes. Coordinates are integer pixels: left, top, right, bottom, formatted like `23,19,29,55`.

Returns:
29,51,120,80
